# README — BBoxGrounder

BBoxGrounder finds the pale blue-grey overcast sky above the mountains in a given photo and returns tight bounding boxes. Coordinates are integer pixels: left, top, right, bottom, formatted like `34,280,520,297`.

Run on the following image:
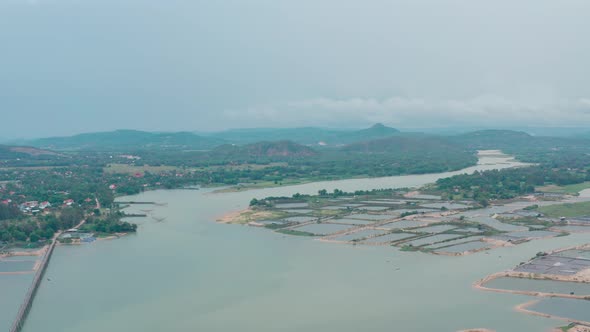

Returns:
0,0,590,138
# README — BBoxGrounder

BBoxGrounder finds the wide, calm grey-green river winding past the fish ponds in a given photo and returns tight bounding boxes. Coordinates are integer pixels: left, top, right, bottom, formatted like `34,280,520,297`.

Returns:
8,157,588,332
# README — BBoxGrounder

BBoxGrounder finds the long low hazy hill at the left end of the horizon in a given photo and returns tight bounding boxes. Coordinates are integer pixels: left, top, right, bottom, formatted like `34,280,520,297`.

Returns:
27,130,225,151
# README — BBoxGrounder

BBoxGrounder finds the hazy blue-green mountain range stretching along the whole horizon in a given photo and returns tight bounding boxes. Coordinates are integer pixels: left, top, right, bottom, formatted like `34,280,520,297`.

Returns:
2,124,590,160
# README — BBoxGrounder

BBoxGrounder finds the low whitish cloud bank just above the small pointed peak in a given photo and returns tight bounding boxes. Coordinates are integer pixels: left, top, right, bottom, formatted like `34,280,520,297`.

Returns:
224,95,590,127
